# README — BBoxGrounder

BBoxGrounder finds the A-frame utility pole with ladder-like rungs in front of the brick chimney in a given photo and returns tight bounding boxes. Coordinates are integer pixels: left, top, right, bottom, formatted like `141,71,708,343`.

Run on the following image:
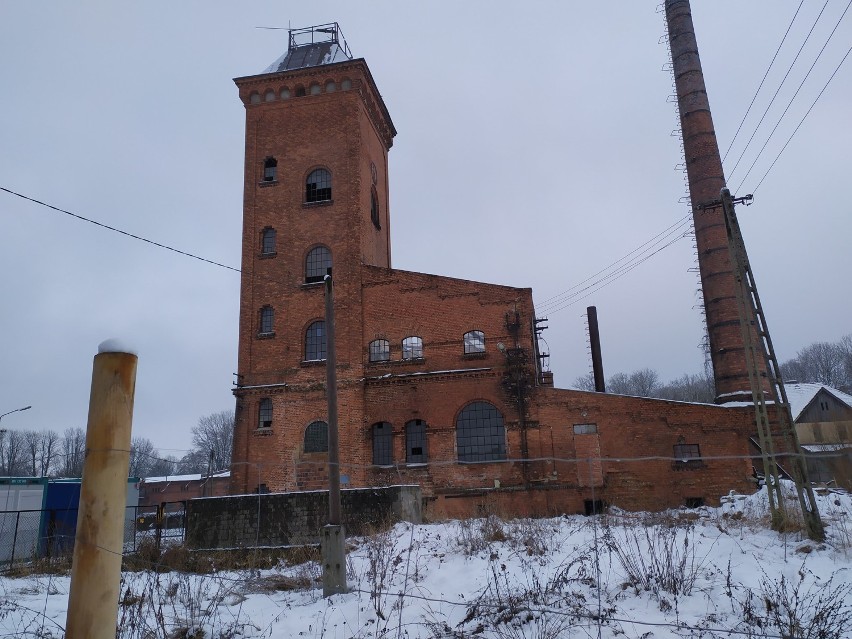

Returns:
713,188,825,540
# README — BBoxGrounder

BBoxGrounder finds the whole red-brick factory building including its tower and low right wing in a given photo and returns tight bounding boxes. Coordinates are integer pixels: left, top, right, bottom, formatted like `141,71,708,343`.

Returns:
231,25,753,517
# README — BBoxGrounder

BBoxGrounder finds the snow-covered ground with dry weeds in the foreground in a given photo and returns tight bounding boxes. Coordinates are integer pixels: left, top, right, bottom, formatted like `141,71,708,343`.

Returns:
0,484,852,639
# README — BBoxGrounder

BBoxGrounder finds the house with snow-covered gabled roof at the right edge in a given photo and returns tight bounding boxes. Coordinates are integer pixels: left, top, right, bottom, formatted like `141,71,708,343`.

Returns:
785,382,852,489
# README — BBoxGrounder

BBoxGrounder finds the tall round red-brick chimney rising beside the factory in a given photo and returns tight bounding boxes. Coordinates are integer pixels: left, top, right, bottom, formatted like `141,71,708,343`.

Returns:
665,0,765,403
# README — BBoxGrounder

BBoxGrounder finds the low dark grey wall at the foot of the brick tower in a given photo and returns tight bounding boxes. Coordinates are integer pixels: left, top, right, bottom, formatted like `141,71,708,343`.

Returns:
186,486,421,548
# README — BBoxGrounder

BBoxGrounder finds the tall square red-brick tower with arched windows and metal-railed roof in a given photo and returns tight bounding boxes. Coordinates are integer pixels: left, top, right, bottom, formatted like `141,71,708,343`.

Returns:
232,23,396,492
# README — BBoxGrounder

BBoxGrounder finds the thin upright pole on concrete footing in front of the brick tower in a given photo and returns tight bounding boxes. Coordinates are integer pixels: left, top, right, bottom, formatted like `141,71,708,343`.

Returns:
320,269,348,597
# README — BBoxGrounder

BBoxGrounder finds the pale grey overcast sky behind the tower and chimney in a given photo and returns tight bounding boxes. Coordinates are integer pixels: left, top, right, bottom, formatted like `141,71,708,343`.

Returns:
0,0,852,456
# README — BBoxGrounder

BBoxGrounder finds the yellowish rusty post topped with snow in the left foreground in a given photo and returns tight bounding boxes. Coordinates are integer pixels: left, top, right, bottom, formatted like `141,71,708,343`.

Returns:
65,340,138,639
